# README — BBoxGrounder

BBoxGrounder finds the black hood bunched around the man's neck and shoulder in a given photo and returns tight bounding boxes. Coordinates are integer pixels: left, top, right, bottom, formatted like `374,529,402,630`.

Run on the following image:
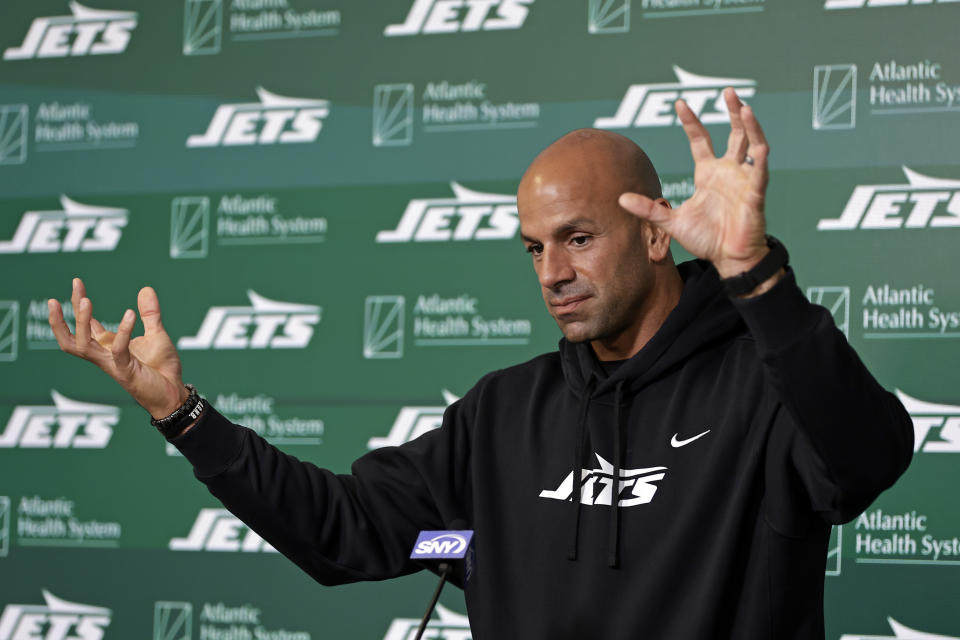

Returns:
559,260,746,401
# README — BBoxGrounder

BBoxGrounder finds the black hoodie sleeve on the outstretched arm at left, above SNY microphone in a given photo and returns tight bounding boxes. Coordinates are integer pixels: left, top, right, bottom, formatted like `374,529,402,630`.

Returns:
171,392,470,585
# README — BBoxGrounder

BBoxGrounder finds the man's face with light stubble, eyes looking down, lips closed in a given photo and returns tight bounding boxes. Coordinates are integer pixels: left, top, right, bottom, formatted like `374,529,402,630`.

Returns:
518,179,653,342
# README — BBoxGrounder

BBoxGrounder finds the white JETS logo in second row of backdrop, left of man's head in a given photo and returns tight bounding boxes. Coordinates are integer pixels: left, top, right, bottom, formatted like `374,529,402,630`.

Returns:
187,87,330,147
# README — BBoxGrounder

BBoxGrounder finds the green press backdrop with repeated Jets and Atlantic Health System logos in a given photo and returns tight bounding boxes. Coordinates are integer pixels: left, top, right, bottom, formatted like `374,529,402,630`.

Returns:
0,0,960,640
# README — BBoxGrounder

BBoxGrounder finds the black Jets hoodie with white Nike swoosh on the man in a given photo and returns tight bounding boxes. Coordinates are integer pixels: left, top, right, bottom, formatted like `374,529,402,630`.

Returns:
174,262,913,640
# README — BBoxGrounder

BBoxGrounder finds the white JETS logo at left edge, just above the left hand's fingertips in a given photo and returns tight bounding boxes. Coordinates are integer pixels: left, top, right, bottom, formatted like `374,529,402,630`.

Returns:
0,196,129,254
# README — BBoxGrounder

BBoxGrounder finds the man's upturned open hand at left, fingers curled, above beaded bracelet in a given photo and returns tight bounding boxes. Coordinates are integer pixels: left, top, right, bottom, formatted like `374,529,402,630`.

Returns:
47,278,189,419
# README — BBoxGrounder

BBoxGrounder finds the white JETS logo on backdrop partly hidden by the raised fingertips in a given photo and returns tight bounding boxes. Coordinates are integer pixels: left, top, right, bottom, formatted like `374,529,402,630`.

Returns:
593,65,757,129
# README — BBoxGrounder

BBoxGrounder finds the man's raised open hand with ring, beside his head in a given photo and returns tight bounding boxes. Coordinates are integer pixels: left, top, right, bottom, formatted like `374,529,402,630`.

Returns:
620,87,769,278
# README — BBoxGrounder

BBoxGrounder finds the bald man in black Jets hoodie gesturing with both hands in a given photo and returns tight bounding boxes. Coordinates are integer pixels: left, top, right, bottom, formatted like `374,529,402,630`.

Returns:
50,89,913,640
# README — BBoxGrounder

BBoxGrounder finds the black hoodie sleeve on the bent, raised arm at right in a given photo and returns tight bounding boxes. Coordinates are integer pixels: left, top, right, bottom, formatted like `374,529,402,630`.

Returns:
733,270,913,523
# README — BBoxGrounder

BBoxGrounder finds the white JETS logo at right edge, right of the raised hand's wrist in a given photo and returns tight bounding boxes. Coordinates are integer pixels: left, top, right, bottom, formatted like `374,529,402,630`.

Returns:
817,167,960,231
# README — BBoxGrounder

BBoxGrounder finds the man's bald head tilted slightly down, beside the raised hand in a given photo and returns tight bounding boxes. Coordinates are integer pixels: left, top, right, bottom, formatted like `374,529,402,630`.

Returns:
517,129,676,358
